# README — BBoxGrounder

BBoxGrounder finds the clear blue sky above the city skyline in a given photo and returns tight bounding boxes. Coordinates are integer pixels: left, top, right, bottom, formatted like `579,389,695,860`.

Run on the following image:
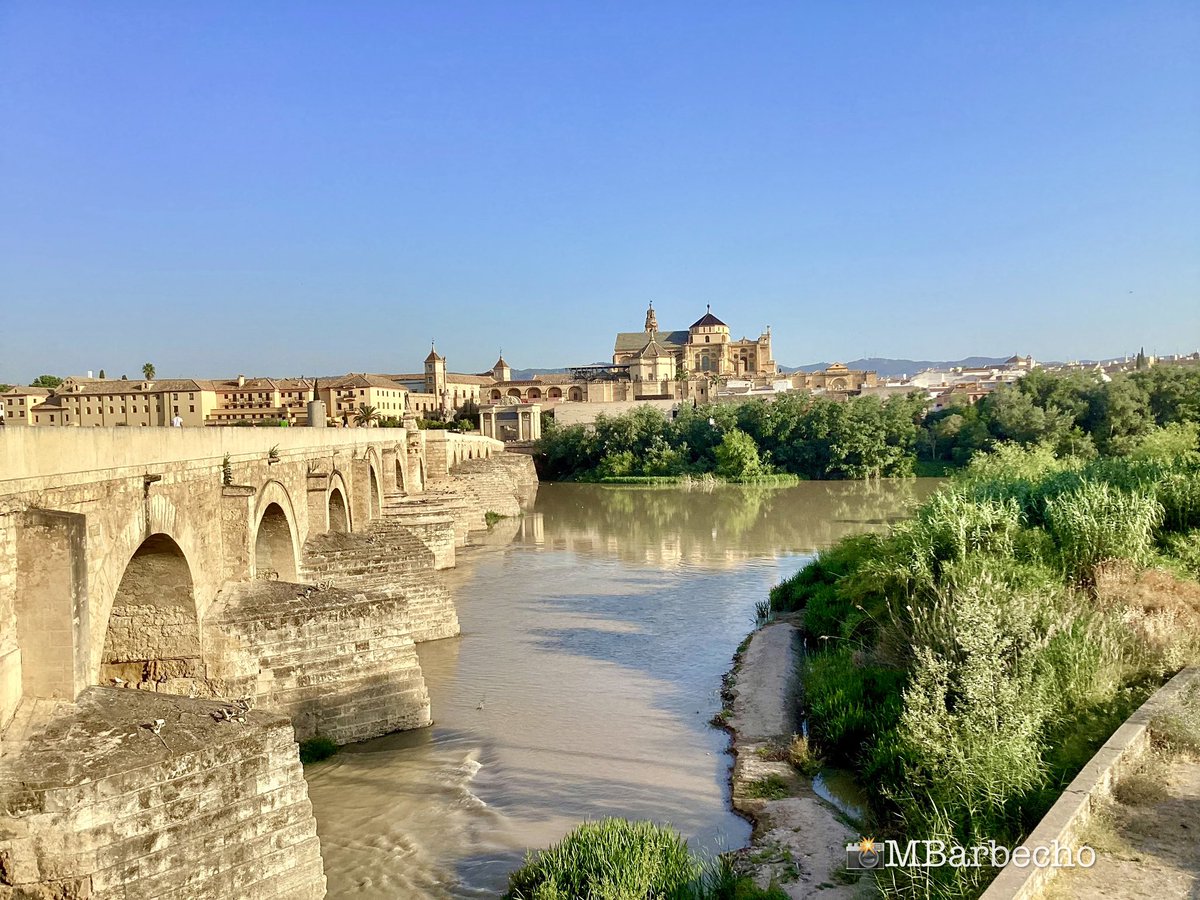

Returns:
0,0,1200,382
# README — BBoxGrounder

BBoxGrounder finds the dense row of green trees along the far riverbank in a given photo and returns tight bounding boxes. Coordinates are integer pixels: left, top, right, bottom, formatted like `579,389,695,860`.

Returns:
540,366,1200,480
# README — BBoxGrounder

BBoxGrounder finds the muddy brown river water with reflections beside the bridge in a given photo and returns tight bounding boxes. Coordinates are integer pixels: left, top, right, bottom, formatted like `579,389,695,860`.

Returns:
308,481,932,898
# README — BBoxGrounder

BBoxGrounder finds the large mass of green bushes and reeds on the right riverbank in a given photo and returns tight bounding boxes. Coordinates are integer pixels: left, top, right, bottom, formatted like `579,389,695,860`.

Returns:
770,433,1200,896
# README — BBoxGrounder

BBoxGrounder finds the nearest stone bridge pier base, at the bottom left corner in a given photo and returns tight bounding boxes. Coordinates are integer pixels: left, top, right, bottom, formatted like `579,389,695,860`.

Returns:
0,688,325,900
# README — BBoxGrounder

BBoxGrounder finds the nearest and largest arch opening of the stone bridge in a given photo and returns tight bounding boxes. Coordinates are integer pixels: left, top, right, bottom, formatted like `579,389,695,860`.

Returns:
98,534,203,694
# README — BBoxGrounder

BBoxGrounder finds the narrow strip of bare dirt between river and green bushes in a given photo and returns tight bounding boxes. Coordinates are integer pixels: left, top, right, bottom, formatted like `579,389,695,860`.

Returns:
727,622,874,900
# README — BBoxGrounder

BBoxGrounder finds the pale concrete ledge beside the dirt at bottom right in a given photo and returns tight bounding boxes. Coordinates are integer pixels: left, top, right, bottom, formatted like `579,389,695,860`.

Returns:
982,668,1200,900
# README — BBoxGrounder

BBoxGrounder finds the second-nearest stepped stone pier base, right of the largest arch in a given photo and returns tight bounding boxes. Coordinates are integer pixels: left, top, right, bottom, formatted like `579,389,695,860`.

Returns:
205,582,431,744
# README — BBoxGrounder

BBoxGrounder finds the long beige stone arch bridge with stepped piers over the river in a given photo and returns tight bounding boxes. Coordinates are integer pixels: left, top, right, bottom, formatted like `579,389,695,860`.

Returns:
0,428,536,898
